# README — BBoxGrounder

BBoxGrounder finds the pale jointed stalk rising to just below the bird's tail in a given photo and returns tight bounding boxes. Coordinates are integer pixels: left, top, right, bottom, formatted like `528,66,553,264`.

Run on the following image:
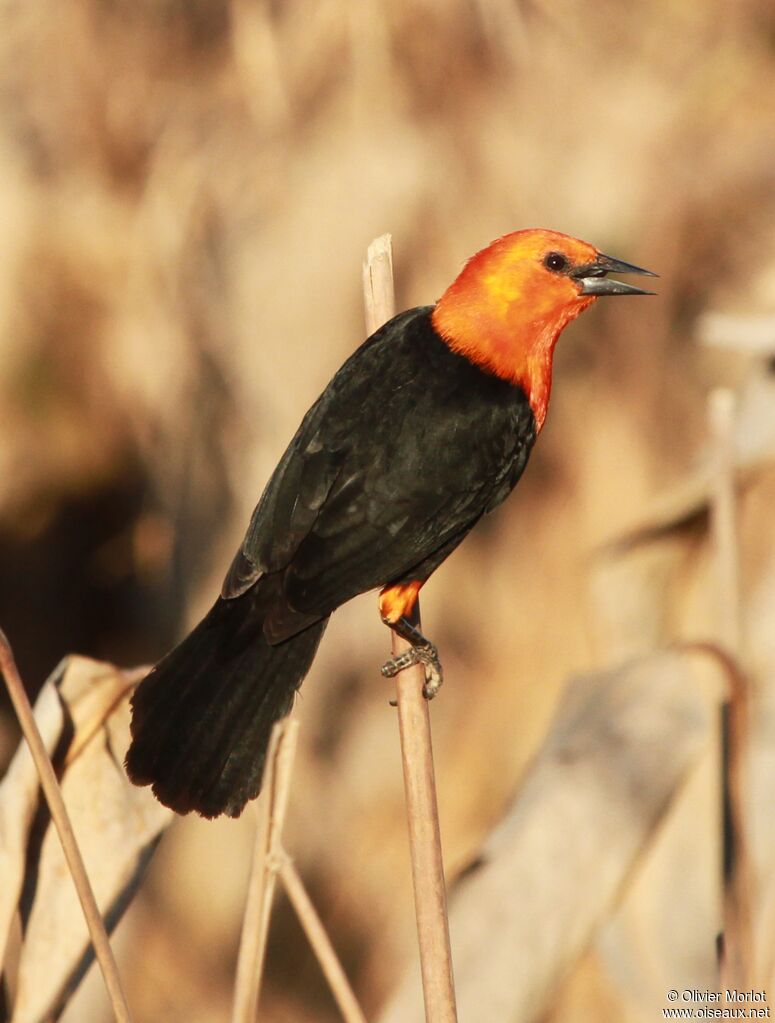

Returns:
231,717,299,1023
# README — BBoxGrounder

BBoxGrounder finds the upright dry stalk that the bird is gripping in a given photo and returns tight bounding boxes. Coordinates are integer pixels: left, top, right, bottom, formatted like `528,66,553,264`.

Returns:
363,234,457,1023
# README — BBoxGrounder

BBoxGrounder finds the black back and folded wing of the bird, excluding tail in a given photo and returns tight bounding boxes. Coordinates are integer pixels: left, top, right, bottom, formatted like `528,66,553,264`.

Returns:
223,307,535,639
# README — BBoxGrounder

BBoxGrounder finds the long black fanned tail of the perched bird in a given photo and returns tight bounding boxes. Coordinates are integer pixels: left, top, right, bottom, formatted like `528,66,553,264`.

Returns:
127,580,328,817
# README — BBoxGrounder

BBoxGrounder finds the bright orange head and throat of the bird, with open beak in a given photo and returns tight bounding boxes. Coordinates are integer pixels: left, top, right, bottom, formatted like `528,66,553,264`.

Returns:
432,229,656,430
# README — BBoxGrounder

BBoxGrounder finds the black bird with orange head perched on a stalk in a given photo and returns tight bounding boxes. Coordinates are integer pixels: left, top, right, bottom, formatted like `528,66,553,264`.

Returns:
126,229,658,817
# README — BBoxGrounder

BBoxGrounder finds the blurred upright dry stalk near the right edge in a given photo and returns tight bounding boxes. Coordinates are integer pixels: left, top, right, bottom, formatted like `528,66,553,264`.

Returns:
709,389,754,989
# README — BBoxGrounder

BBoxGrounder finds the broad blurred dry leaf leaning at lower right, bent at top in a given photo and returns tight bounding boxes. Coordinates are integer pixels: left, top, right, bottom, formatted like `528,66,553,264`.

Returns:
380,653,723,1023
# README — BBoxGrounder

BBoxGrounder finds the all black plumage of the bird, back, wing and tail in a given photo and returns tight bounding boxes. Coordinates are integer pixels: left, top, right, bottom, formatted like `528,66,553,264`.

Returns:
127,307,536,816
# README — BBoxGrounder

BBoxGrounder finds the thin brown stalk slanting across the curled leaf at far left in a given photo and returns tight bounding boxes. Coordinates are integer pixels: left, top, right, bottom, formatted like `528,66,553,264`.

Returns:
0,630,132,1023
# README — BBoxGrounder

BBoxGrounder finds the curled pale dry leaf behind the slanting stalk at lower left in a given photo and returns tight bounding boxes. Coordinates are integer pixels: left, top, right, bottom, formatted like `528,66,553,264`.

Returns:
0,657,173,1023
